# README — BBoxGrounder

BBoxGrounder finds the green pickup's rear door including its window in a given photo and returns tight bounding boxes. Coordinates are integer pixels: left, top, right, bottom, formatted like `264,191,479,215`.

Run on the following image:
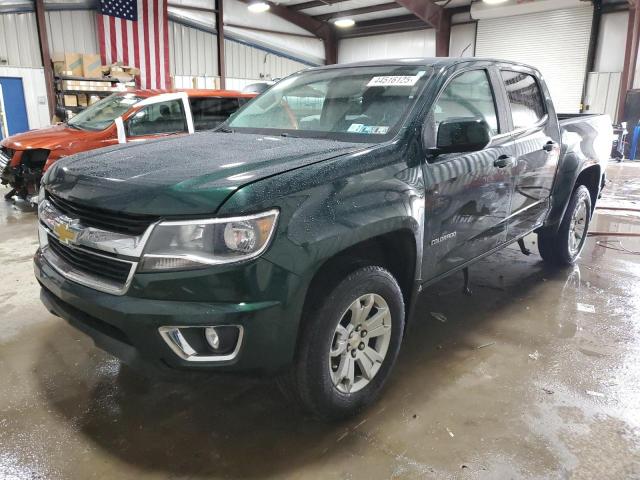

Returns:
500,65,560,239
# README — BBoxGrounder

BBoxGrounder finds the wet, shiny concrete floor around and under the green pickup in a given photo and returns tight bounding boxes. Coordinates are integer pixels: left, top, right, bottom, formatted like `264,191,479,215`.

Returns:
0,164,640,480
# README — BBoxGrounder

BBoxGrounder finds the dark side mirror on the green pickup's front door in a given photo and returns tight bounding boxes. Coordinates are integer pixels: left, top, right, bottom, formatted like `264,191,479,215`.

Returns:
434,118,491,154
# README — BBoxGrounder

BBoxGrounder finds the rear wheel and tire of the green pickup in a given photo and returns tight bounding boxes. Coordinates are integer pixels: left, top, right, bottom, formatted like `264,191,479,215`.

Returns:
538,185,592,266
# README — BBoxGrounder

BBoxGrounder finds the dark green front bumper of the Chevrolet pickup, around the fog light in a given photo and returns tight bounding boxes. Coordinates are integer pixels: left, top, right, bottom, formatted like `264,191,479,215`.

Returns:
34,251,302,375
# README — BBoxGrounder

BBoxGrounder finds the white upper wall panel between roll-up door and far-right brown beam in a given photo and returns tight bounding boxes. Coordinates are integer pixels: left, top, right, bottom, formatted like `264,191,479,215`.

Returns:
593,12,629,72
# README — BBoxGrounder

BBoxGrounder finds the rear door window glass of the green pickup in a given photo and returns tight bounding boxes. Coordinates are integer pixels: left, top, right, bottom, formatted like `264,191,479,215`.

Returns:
500,70,545,129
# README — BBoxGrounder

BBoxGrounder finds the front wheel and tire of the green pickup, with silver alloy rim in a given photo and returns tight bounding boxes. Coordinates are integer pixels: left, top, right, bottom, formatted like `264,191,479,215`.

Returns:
279,266,405,420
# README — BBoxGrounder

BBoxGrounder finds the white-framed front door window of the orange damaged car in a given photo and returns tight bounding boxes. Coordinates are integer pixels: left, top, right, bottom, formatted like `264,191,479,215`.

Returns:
127,100,187,137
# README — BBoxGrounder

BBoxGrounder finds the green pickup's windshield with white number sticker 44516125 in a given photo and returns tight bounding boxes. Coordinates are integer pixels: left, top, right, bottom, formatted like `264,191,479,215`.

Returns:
227,65,431,142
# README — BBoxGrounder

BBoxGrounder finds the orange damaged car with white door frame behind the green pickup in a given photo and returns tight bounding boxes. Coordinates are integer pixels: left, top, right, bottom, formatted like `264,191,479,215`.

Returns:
0,90,256,202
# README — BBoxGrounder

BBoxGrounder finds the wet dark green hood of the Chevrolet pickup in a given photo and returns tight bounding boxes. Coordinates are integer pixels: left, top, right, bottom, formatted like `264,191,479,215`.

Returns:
45,132,371,216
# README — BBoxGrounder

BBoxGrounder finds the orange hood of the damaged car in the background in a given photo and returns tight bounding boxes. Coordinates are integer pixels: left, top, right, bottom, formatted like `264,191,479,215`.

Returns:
2,124,101,150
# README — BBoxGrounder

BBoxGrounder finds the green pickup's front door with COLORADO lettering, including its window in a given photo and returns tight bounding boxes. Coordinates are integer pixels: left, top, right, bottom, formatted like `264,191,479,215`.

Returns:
423,69,515,280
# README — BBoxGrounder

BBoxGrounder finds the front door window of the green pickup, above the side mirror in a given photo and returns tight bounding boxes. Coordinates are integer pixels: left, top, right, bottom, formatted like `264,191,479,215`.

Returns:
433,70,498,135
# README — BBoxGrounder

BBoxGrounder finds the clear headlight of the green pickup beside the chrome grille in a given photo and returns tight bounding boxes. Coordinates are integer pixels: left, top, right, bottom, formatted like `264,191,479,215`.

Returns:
140,210,278,272
